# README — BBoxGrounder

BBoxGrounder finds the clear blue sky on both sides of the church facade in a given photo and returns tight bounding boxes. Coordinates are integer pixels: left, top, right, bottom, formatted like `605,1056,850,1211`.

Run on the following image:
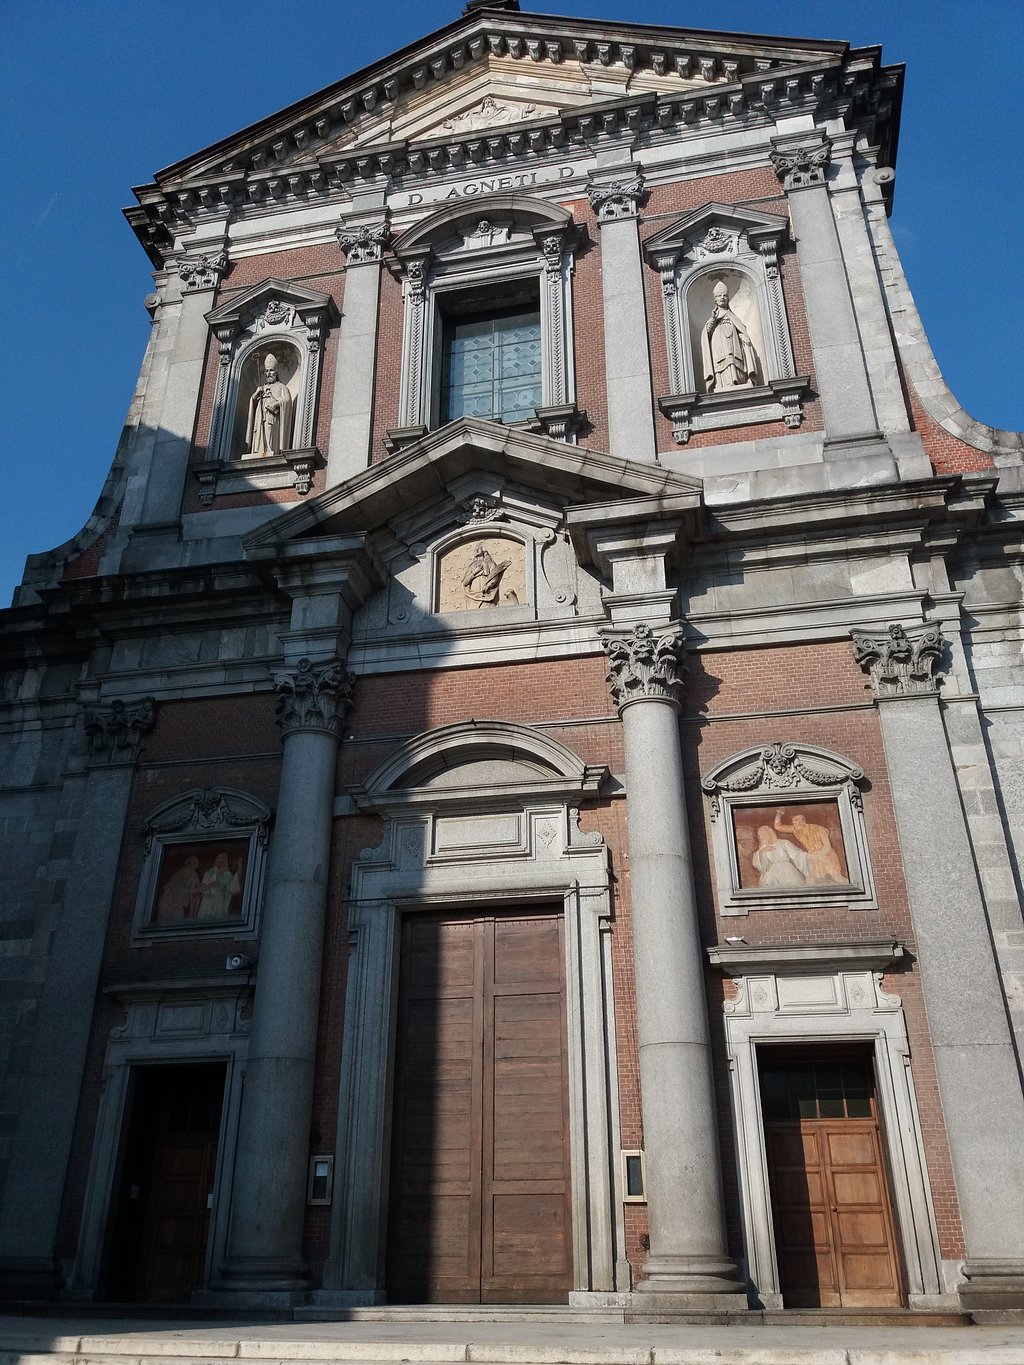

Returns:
0,0,1024,603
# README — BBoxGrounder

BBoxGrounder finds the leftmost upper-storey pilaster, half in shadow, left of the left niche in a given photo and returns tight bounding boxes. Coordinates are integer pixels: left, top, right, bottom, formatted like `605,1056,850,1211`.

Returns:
127,242,227,540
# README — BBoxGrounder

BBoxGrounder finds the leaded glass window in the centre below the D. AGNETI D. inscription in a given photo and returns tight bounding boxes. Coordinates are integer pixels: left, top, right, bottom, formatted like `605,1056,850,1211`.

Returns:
441,304,542,422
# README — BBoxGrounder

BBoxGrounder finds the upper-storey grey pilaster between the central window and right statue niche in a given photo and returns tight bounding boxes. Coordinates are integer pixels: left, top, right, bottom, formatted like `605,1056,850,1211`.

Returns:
587,167,657,460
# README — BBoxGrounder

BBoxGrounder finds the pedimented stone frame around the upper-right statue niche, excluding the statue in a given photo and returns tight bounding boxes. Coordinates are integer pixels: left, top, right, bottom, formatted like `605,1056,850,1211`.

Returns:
643,203,810,445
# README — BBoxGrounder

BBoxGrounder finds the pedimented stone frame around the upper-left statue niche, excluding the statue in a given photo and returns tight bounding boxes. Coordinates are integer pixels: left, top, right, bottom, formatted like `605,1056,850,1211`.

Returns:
195,280,337,502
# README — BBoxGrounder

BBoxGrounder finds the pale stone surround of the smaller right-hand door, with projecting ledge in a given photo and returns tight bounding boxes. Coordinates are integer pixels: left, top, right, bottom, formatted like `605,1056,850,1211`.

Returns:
709,939,960,1309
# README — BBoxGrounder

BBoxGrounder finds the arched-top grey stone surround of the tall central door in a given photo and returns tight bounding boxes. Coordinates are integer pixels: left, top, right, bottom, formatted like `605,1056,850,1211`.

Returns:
319,721,629,1308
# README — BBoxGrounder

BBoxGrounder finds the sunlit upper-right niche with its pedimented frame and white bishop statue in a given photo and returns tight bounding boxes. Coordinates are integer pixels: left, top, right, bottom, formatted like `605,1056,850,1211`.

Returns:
643,203,808,445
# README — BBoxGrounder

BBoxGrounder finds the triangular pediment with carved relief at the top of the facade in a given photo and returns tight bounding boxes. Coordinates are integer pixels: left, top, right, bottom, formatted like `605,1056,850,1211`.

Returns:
148,10,862,191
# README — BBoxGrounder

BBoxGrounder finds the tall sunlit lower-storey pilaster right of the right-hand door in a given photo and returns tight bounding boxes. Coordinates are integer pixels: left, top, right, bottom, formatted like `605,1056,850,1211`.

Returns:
853,625,1024,1309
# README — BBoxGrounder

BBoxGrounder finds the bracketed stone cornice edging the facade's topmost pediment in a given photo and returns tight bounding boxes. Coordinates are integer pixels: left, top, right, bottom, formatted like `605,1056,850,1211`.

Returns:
126,12,902,265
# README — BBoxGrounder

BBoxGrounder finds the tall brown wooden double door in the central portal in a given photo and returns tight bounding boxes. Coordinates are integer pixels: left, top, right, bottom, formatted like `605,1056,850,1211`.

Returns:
388,913,572,1304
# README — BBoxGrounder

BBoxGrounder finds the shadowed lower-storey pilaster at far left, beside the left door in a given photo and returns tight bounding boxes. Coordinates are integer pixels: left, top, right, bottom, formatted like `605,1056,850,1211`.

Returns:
0,698,154,1297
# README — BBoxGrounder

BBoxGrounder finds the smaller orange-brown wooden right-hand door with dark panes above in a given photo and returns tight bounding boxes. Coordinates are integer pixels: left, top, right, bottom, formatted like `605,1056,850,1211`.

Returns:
760,1055,902,1308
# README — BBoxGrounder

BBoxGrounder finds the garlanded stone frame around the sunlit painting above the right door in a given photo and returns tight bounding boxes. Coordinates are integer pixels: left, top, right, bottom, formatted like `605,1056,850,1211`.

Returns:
700,743,878,915
